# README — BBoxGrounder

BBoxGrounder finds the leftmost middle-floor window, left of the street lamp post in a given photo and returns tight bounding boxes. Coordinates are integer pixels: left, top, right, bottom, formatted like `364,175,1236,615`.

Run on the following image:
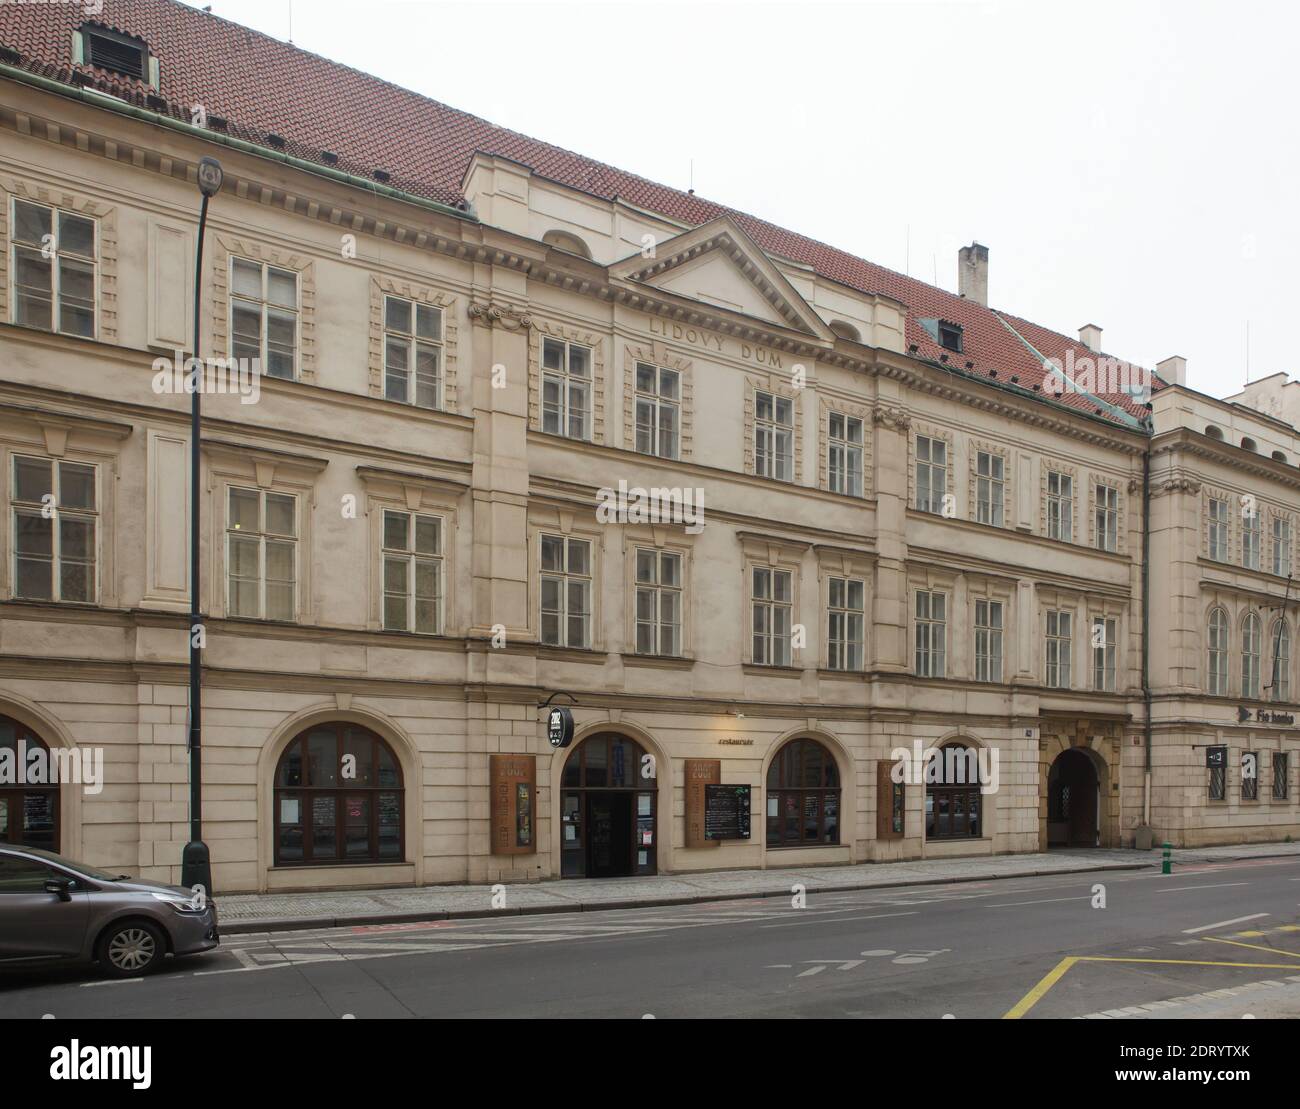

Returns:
13,455,99,603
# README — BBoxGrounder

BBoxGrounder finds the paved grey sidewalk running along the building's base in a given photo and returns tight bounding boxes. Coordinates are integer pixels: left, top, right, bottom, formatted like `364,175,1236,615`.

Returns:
216,844,1300,935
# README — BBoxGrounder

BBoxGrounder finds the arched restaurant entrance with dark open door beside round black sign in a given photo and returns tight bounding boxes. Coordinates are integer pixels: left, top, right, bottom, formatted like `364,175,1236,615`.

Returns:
560,732,659,878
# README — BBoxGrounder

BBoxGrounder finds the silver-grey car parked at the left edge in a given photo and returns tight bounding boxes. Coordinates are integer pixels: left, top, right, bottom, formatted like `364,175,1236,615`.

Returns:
0,844,220,978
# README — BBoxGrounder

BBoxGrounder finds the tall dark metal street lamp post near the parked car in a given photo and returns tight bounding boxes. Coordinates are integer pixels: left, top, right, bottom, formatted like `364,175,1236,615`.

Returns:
181,157,224,897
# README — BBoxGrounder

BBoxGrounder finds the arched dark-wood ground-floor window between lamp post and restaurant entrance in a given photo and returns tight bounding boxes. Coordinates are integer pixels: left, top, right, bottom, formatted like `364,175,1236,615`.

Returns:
274,722,406,866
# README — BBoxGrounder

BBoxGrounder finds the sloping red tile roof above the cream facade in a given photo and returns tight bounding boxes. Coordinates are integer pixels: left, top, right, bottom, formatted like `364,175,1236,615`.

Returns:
0,0,1162,423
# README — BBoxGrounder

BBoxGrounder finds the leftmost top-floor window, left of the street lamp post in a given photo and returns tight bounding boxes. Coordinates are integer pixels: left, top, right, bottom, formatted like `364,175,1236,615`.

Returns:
10,198,99,339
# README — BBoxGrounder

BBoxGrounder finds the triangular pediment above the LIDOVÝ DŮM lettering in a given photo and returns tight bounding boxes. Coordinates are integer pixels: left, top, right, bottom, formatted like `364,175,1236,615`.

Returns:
610,216,835,341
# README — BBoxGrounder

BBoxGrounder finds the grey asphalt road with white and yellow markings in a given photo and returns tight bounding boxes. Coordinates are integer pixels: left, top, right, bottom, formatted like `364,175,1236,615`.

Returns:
0,858,1300,1019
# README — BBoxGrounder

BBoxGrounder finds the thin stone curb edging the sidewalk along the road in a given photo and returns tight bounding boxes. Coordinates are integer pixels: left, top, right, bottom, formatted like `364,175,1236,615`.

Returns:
216,855,1154,936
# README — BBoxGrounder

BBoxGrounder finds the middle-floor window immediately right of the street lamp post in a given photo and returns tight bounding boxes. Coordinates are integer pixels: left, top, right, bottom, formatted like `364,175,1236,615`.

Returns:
226,486,298,620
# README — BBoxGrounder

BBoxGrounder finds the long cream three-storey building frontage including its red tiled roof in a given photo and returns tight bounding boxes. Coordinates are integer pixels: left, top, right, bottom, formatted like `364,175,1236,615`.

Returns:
0,0,1300,892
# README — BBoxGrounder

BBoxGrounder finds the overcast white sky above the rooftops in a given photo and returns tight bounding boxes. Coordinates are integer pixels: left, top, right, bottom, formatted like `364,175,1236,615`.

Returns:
195,0,1300,395
